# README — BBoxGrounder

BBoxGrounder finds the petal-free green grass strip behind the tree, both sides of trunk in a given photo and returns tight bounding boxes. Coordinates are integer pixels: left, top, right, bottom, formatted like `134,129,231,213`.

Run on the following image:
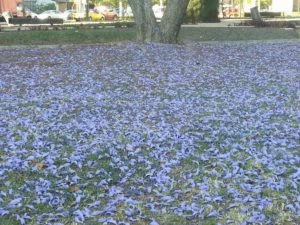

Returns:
0,27,299,46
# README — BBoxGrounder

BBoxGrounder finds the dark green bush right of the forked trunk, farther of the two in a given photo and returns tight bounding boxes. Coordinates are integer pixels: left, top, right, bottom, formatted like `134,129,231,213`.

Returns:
200,0,219,22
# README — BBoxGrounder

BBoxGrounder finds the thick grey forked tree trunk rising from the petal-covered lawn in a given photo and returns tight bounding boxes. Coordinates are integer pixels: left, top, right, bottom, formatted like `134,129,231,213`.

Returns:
128,0,189,43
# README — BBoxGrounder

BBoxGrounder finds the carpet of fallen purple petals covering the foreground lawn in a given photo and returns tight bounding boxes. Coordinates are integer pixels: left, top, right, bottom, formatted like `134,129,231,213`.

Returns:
0,41,300,225
